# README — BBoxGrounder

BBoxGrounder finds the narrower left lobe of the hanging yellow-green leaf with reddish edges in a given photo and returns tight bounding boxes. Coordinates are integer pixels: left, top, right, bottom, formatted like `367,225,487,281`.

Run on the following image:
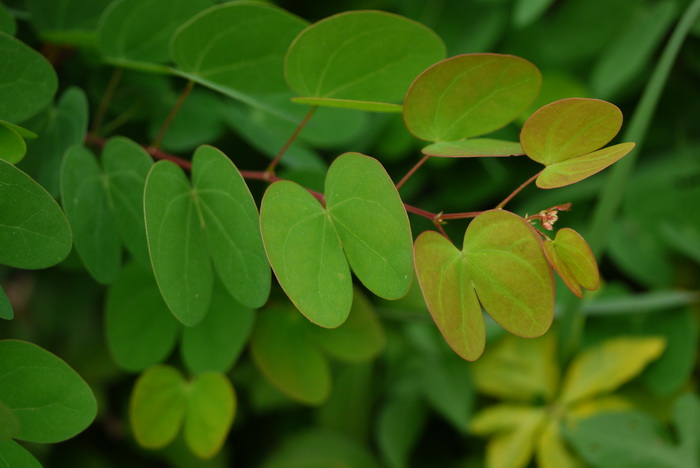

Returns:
415,231,486,361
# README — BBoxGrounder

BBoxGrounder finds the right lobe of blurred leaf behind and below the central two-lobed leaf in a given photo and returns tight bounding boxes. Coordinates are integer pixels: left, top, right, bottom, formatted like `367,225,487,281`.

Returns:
311,290,386,362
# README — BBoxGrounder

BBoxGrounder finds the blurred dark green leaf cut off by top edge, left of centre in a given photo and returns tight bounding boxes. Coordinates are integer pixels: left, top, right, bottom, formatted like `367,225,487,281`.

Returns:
97,0,211,63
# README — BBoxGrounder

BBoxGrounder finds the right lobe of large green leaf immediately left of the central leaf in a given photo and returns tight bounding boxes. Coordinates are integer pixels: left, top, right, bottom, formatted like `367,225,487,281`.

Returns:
192,146,271,308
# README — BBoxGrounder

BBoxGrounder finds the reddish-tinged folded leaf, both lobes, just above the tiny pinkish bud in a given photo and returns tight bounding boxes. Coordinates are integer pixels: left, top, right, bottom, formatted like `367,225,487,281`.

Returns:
520,98,634,189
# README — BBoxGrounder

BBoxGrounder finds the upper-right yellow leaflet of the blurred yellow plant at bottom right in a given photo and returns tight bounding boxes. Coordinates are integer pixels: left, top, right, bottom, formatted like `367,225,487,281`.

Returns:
560,337,666,404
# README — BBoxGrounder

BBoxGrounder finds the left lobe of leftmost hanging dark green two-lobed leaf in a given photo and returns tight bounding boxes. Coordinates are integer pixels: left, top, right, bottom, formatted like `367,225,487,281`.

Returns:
61,146,122,284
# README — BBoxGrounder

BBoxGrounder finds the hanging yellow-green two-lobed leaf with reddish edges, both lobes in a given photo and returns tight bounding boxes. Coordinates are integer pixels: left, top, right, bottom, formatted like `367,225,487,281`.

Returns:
415,210,554,360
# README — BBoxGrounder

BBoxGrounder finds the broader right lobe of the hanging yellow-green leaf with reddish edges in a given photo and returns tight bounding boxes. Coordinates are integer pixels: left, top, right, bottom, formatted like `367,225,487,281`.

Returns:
463,210,554,338
